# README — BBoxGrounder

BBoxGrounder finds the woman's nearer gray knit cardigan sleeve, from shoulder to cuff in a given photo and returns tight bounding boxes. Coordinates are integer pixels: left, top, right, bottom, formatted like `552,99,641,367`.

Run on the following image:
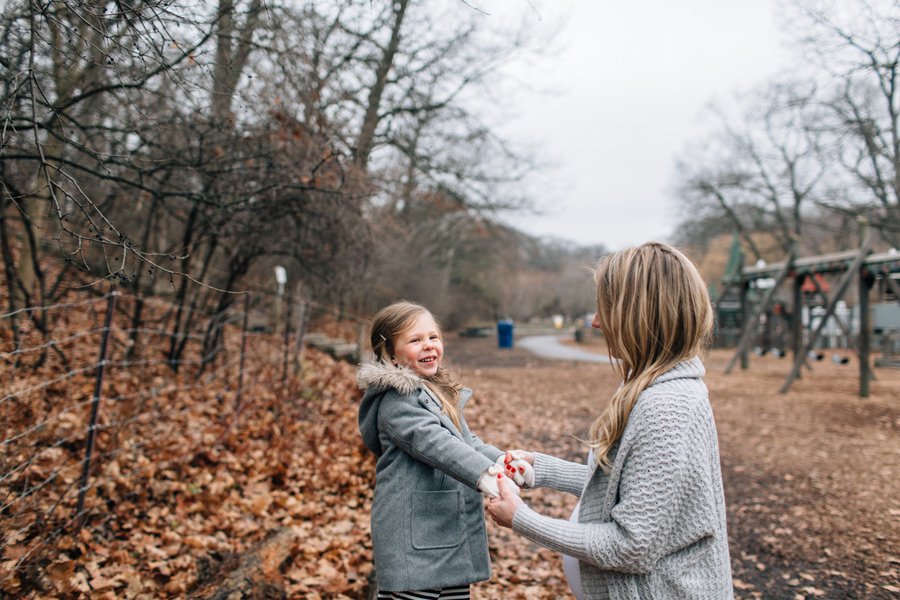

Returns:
513,402,709,573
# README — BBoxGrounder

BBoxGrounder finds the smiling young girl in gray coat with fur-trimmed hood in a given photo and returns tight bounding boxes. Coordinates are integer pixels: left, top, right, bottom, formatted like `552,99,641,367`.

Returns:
357,302,518,599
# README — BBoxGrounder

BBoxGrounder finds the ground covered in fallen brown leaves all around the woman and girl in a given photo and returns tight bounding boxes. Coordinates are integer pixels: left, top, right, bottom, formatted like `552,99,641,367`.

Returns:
7,324,900,600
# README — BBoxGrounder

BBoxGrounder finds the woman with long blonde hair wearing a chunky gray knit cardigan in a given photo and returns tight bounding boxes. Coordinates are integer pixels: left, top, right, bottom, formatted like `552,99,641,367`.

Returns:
488,243,734,600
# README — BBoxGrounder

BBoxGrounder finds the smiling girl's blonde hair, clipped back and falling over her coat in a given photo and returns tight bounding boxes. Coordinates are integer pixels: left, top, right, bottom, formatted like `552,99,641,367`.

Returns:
369,300,462,430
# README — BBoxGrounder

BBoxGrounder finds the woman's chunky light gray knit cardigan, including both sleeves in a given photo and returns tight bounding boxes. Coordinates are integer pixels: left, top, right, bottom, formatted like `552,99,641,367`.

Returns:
513,358,734,600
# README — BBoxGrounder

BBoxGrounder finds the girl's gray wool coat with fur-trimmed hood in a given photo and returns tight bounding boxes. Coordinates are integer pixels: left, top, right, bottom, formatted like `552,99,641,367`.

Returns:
357,362,503,591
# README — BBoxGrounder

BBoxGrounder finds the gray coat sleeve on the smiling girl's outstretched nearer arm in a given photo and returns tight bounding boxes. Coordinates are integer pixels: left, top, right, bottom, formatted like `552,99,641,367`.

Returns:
378,392,499,489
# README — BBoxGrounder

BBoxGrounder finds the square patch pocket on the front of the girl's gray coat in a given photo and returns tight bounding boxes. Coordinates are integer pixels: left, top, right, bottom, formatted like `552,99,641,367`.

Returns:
412,490,463,550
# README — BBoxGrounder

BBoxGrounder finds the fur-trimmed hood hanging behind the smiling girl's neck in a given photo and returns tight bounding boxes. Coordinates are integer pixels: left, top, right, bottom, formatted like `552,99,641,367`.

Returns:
356,361,426,456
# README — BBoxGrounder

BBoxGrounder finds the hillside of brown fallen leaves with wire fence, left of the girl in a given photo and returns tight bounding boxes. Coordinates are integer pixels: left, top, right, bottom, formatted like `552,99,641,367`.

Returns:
0,296,371,600
